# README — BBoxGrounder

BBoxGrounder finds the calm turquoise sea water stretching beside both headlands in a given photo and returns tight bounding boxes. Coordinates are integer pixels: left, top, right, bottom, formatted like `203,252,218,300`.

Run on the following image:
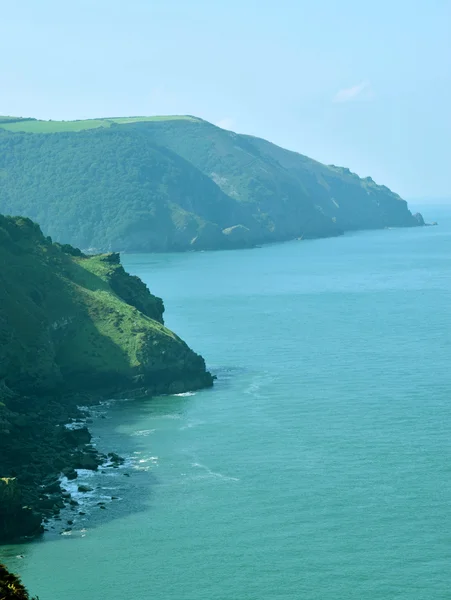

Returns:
0,207,451,600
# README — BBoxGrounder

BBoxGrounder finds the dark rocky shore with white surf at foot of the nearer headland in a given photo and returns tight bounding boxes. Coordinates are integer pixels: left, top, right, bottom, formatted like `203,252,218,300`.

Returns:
0,385,214,544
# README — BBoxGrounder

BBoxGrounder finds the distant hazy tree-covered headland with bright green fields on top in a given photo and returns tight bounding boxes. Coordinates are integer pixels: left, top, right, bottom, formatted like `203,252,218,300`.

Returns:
0,116,423,252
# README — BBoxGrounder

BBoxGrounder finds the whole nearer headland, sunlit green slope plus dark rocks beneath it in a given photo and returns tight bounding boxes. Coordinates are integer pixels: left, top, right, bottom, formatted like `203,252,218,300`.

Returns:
0,215,212,541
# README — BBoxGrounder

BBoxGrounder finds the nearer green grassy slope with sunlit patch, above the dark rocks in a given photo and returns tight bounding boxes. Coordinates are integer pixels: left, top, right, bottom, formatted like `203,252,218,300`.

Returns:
0,217,211,394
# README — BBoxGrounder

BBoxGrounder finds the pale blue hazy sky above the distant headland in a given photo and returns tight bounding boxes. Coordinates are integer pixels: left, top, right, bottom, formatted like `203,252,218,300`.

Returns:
0,0,451,198
